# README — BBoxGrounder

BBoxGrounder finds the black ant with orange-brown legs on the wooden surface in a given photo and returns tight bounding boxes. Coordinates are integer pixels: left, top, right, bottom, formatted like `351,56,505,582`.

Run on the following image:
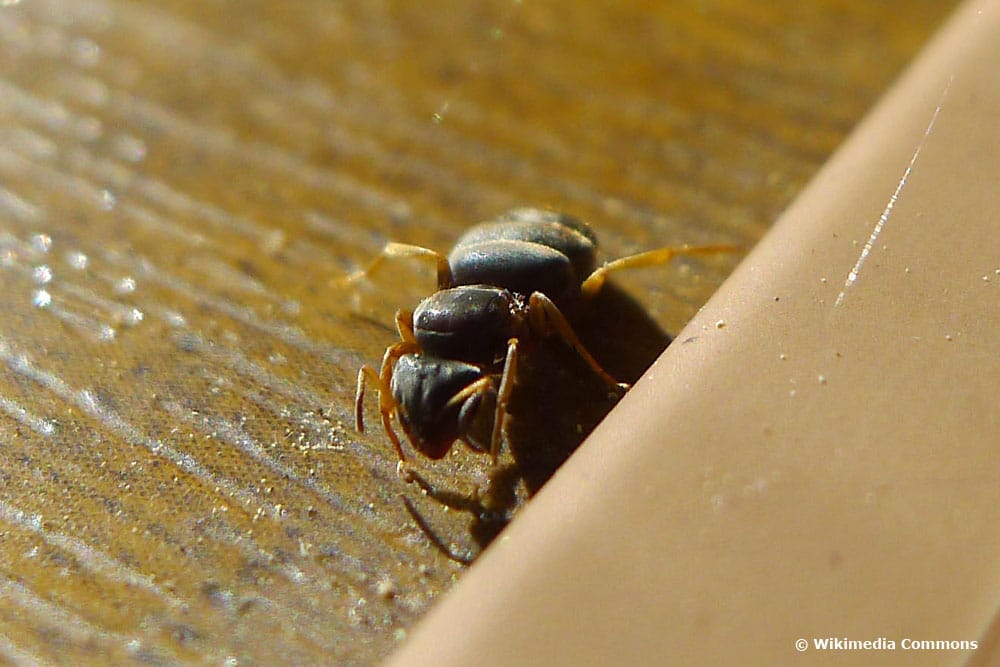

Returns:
344,208,737,474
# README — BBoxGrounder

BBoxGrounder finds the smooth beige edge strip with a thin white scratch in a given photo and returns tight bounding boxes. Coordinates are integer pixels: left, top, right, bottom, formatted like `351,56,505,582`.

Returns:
392,0,1000,667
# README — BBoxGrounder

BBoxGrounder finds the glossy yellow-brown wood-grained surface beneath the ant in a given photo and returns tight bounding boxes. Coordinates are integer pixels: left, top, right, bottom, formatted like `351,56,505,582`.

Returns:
0,0,960,664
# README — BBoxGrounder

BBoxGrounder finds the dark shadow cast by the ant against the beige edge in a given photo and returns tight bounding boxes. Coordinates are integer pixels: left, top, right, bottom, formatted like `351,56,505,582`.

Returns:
403,283,671,564
